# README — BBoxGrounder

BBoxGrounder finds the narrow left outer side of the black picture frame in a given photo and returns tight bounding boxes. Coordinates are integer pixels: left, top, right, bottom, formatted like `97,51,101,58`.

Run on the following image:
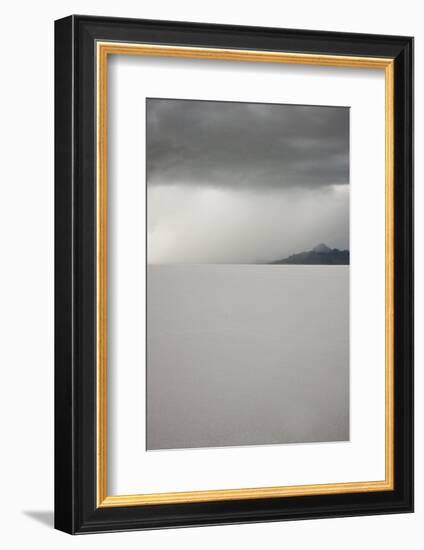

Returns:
54,16,76,534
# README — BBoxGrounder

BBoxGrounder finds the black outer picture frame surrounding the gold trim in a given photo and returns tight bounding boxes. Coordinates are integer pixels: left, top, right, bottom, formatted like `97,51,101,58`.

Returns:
55,15,413,534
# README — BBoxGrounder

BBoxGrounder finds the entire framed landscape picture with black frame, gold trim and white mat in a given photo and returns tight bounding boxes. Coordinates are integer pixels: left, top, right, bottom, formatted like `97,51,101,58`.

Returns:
55,16,413,534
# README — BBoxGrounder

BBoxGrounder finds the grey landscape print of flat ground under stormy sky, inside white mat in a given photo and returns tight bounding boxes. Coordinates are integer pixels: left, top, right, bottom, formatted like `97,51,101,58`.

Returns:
146,98,350,451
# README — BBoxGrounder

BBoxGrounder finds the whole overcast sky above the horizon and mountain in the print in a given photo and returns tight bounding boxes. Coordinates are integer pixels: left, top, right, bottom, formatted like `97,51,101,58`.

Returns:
146,99,349,263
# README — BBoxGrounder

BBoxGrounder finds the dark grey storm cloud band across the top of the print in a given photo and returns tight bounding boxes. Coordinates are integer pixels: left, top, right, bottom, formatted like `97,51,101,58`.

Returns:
146,99,349,191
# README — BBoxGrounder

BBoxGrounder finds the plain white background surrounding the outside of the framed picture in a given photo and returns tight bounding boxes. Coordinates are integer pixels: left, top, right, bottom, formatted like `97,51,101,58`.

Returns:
0,0,424,549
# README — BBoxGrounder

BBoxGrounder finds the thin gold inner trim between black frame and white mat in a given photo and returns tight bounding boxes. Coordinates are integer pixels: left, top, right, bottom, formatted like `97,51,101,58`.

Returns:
96,42,394,508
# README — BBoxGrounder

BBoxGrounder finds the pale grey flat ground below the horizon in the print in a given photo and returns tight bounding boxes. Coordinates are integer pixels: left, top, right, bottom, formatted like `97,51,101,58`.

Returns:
146,264,349,450
